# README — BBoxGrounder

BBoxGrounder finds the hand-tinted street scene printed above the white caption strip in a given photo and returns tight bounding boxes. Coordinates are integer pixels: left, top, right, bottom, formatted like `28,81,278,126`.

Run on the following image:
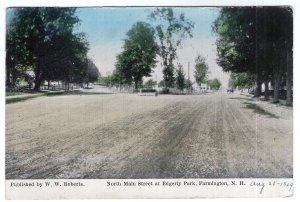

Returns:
5,6,294,181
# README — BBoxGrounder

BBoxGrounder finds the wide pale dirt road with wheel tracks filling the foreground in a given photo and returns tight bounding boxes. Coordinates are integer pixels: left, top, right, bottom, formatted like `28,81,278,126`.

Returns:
6,93,293,179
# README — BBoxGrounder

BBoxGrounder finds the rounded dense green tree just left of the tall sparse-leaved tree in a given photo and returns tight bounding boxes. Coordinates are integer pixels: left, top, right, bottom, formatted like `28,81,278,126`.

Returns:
116,22,157,89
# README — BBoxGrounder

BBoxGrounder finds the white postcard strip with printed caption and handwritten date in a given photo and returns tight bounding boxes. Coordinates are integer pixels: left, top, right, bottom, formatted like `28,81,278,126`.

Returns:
6,178,293,200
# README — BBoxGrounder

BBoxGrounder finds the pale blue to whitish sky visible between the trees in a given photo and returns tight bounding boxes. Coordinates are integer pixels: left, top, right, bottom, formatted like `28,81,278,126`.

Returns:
77,7,229,88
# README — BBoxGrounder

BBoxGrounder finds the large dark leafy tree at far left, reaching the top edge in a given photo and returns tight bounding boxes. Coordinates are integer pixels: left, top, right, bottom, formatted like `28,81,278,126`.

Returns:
8,8,88,90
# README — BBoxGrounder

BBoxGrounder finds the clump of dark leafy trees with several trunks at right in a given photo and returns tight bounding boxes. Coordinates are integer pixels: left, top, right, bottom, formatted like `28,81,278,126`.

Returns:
213,7,293,103
